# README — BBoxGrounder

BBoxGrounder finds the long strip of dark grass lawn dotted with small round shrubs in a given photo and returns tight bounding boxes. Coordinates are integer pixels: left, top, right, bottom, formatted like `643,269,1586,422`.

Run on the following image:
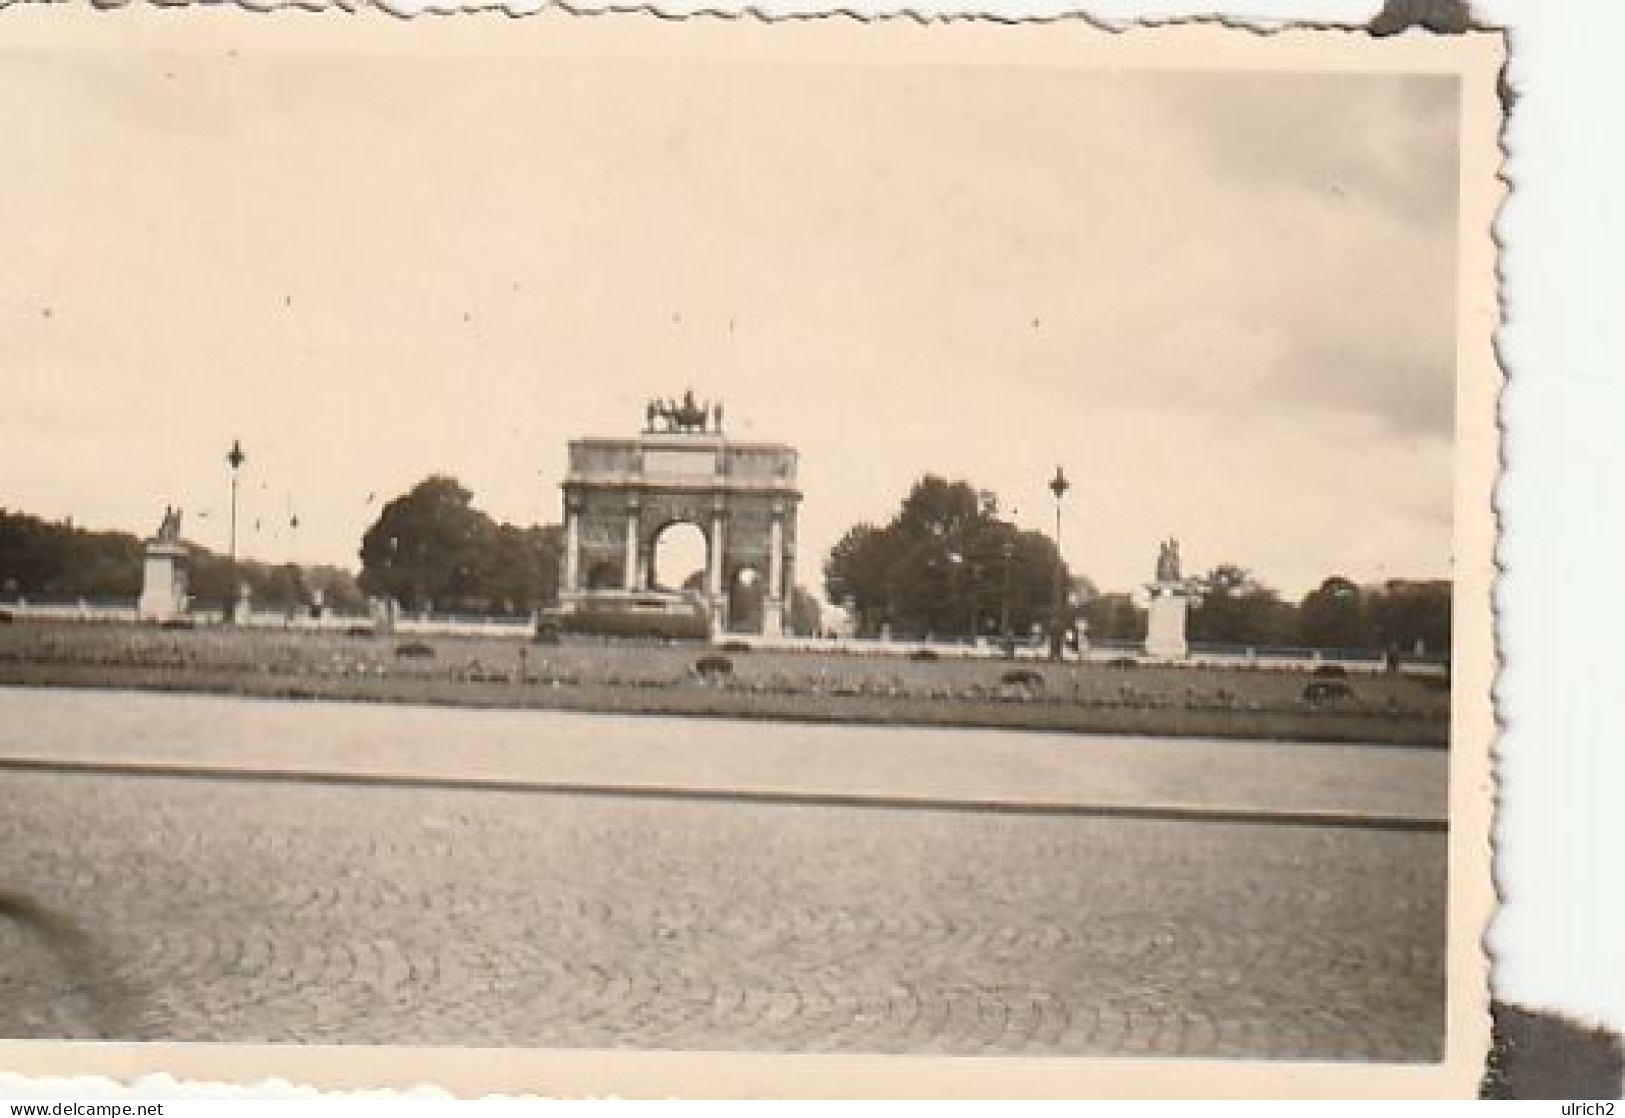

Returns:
0,622,1450,746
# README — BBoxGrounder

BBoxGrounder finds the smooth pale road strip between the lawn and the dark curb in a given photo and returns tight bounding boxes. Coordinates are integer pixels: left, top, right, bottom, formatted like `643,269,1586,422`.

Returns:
0,687,1450,824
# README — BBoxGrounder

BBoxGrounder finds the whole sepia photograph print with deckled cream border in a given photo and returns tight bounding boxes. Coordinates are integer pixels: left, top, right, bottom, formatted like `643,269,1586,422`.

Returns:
0,11,1498,1082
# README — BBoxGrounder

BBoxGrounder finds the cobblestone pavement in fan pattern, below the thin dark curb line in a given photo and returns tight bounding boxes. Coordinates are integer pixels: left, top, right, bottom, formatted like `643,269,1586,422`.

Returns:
0,772,1446,1060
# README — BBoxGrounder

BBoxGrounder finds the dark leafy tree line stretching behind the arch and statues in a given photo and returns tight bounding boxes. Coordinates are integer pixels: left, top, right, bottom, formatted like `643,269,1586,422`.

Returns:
0,476,1451,653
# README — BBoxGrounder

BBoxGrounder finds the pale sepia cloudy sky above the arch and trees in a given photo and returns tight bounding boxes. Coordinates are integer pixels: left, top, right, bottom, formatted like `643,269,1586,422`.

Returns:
0,21,1458,596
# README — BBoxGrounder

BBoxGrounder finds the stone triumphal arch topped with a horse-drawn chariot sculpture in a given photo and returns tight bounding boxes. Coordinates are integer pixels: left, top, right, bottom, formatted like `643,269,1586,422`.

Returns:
559,393,801,637
